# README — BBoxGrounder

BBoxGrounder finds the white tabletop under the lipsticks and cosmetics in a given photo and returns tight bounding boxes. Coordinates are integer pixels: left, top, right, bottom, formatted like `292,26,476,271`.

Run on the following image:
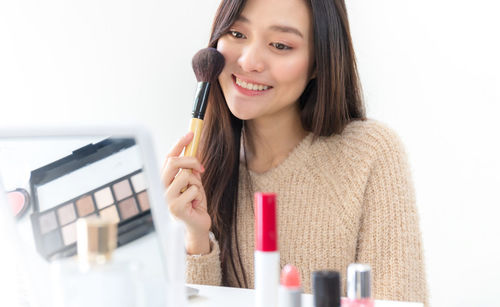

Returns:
188,284,424,307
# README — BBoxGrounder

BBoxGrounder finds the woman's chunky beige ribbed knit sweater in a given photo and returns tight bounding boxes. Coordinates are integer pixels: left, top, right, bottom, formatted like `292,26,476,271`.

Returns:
187,120,427,303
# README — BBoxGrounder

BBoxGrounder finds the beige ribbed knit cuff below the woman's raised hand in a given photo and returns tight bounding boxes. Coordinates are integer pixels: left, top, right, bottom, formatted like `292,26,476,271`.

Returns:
186,234,222,286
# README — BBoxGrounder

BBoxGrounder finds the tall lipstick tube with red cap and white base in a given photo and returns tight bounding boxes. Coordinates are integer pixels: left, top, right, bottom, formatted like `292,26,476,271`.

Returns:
254,193,280,307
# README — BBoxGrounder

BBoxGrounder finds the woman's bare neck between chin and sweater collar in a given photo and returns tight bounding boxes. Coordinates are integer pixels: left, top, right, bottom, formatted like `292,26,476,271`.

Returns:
245,106,307,173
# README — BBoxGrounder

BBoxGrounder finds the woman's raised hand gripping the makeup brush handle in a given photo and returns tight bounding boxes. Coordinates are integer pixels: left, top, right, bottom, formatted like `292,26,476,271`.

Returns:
162,132,212,254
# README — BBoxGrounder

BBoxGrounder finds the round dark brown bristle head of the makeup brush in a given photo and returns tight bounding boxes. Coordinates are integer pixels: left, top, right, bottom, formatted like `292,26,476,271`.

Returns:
193,48,226,82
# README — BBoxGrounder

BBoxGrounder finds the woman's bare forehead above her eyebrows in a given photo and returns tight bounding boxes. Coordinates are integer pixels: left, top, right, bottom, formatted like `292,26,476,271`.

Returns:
239,0,311,36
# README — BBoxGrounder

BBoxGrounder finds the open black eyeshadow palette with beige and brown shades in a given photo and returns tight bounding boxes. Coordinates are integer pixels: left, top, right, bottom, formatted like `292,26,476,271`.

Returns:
31,140,154,260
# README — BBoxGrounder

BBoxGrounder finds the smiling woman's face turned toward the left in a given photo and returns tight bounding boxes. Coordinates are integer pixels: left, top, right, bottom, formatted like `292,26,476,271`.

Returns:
217,0,313,120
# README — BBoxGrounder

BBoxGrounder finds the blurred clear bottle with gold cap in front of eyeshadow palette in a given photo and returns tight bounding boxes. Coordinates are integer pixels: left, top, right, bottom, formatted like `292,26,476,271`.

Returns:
51,217,144,307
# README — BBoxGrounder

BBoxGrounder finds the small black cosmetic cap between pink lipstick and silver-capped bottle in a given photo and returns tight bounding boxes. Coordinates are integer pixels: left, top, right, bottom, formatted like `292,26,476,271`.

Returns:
312,271,340,307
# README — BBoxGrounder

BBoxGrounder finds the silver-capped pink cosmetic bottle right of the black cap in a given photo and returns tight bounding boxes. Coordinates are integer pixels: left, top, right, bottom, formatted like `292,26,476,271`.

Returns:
342,263,374,307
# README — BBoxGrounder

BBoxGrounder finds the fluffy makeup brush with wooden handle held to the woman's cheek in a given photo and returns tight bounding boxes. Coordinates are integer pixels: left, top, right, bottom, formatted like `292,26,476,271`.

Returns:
182,48,225,192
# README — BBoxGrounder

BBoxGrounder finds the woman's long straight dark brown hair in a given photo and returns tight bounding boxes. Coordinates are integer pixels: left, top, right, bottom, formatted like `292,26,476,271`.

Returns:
200,0,365,287
